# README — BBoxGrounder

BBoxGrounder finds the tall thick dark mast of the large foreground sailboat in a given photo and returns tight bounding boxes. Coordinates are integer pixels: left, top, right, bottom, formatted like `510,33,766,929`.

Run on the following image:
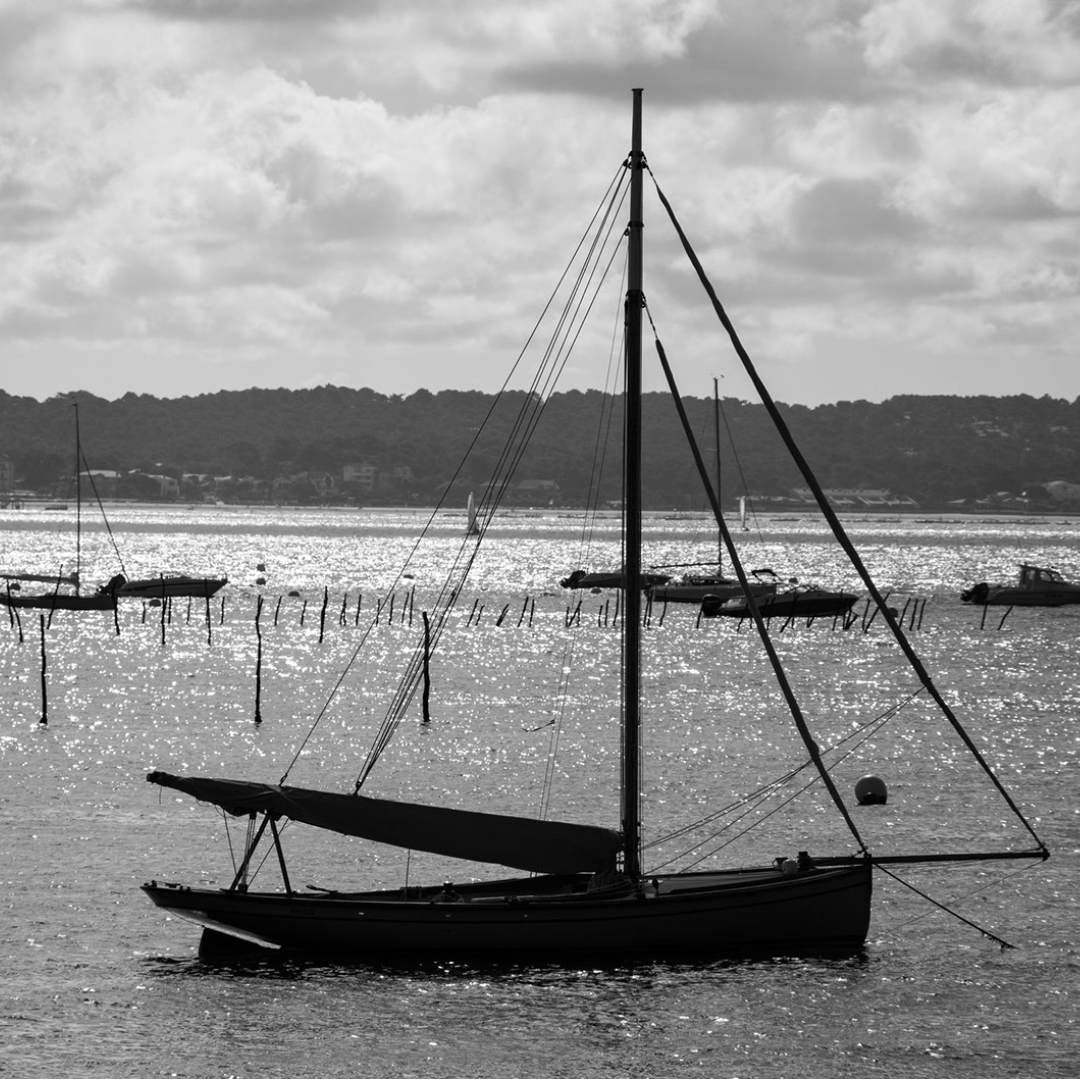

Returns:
622,90,645,878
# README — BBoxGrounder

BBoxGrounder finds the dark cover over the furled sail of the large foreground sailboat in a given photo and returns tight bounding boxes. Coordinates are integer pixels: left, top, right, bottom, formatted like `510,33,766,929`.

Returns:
146,772,622,874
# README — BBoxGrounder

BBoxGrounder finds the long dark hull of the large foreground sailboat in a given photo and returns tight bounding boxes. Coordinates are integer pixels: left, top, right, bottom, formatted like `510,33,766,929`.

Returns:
143,864,872,958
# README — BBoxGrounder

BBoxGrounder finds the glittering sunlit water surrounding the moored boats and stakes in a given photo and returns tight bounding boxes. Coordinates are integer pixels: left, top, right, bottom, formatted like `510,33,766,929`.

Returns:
0,508,1080,1077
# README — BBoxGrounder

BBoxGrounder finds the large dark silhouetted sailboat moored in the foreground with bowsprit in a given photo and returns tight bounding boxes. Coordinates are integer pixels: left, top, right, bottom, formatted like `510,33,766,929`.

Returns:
143,90,1048,962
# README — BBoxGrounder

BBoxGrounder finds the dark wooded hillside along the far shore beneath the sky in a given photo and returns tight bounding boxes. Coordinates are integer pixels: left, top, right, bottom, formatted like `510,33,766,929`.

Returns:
0,386,1080,510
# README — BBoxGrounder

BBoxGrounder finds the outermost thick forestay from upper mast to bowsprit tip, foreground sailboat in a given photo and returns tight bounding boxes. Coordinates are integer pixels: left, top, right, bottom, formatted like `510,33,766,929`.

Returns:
645,165,1047,851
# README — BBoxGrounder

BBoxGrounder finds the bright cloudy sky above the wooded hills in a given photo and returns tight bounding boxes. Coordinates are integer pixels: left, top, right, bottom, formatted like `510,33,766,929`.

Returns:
0,0,1080,405
